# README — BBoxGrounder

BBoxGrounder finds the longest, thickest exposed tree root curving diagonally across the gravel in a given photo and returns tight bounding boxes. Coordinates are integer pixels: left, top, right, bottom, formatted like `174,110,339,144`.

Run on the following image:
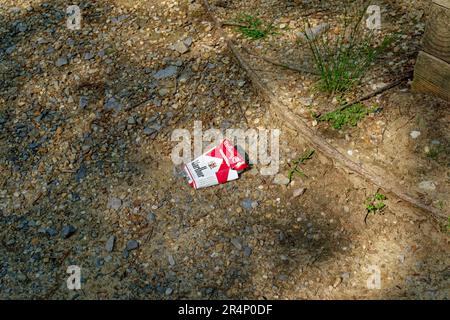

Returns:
203,0,447,220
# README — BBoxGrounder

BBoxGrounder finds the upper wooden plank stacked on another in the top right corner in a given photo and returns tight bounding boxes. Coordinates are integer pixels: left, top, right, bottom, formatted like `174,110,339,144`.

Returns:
423,0,450,63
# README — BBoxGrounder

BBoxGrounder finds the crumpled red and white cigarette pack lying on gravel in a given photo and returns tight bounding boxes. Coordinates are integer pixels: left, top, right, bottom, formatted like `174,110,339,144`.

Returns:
184,139,248,189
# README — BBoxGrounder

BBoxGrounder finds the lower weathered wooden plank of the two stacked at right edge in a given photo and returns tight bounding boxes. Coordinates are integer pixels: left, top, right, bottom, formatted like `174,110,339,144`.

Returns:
412,51,450,102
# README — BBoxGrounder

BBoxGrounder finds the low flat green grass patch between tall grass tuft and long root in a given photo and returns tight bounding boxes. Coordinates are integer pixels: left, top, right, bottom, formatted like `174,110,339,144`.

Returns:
318,103,376,130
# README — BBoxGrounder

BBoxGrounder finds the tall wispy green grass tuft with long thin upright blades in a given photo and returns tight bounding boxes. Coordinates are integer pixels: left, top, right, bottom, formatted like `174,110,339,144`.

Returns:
304,7,394,94
